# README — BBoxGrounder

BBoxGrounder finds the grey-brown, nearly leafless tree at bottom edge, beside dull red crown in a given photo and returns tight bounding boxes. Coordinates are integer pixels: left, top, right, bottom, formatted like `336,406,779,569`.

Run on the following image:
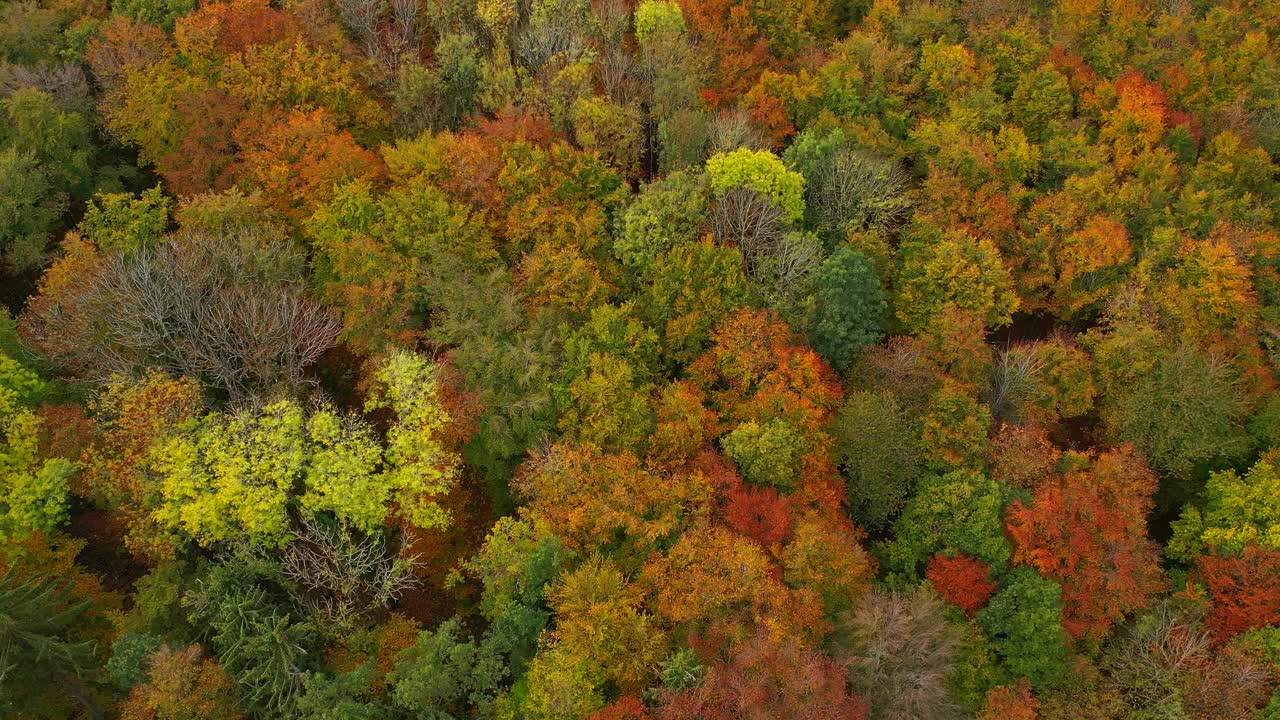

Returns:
832,588,960,720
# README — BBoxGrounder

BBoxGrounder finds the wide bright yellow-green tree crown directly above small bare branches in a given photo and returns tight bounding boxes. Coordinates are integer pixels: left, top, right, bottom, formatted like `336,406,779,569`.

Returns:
150,351,457,546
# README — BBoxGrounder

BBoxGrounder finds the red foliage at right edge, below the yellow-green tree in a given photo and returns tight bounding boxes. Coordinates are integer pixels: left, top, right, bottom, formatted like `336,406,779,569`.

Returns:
1197,546,1280,642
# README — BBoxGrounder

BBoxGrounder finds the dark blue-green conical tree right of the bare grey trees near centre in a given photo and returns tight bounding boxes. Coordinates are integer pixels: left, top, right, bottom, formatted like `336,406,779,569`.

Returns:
809,246,887,370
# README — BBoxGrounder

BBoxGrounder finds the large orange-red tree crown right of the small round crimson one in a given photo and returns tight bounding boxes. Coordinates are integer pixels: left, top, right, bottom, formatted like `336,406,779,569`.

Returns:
1007,447,1164,641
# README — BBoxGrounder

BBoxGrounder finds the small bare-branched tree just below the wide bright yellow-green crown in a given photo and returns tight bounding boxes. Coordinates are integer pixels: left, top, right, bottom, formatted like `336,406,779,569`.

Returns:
277,516,420,629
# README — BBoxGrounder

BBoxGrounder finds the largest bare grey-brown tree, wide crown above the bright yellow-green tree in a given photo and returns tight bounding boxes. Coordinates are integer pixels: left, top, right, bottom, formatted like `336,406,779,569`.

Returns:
23,228,340,400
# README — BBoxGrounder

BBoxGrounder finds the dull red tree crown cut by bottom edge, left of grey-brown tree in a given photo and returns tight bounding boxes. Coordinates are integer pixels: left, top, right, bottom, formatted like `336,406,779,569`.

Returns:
659,629,869,720
